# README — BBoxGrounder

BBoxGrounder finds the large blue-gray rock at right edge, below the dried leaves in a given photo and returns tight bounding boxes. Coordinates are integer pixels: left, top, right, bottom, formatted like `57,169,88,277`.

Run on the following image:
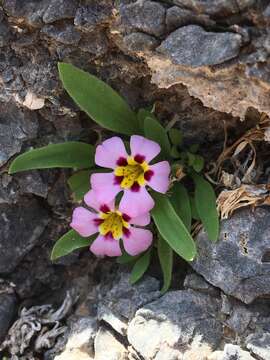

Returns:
191,208,270,304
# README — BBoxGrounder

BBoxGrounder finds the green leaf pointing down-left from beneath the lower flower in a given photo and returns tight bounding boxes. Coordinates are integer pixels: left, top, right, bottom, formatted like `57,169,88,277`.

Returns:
51,230,96,260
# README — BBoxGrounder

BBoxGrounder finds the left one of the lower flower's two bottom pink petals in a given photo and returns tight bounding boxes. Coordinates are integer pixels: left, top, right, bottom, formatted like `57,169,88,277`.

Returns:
90,235,122,256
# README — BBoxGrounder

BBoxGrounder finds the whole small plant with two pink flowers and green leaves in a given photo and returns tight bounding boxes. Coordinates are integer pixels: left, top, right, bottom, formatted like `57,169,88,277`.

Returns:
9,63,219,292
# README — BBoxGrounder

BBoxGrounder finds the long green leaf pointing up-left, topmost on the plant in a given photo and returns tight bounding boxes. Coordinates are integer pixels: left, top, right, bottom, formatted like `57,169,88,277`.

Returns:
58,63,141,135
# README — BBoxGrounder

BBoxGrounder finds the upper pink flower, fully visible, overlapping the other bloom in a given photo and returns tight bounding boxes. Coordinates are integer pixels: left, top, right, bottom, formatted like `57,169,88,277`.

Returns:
91,135,170,217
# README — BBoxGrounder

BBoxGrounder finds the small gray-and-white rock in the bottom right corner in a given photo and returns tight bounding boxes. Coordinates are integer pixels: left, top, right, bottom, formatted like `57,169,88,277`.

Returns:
246,332,270,360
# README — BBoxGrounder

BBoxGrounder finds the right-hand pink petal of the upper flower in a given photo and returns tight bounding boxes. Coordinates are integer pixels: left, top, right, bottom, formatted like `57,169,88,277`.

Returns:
147,161,171,194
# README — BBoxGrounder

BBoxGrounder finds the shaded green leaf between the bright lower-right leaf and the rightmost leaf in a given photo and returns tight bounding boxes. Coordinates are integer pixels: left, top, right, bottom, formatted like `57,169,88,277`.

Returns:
170,182,191,231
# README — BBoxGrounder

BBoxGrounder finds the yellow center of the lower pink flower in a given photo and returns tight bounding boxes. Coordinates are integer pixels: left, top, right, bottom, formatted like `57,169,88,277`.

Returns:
99,210,129,240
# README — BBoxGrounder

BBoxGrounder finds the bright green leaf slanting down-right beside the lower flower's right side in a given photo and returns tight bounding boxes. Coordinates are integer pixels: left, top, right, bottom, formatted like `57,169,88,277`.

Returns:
152,193,196,261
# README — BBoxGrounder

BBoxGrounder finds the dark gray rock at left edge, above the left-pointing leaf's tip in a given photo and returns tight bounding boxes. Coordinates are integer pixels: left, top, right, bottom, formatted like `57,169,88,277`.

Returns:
0,103,38,166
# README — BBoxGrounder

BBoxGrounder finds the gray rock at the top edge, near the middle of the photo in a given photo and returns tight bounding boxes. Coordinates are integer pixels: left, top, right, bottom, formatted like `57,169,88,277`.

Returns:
120,0,166,36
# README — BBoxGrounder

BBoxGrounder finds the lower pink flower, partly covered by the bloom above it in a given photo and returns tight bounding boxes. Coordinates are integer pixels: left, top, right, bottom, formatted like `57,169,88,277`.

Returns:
70,190,153,256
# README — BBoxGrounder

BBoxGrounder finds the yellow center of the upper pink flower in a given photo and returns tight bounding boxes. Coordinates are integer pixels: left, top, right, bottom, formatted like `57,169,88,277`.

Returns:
114,156,151,189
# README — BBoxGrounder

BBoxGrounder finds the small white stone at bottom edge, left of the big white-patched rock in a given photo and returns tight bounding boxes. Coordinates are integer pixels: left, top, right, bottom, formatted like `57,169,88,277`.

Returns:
95,327,127,360
